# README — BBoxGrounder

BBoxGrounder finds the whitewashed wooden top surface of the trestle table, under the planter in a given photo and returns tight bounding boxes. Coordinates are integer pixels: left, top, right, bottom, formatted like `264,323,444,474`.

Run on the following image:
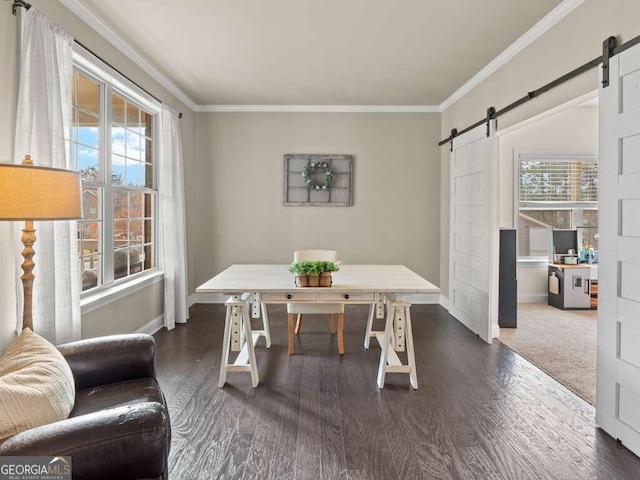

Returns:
196,264,440,294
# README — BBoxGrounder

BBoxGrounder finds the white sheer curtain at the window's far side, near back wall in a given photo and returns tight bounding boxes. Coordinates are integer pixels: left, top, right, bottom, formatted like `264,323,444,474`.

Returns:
158,105,189,330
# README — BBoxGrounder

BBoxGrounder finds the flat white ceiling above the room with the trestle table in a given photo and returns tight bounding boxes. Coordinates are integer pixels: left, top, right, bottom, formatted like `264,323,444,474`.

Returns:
74,0,561,105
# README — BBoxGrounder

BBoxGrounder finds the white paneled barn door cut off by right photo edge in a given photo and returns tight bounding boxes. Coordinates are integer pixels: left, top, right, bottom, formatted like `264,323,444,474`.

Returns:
596,40,640,455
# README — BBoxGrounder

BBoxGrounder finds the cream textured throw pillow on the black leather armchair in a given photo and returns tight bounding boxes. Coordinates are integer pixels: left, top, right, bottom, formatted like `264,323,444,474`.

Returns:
0,328,76,439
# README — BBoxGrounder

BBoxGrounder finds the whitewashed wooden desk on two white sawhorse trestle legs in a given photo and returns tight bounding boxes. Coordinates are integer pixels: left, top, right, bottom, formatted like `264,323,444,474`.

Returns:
196,265,440,389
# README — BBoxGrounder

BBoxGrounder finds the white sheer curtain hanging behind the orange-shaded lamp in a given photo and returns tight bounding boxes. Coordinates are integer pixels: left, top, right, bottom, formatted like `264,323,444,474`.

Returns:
14,7,80,343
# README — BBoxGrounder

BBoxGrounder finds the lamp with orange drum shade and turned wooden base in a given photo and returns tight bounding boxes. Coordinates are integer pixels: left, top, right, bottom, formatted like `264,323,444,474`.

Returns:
0,155,82,330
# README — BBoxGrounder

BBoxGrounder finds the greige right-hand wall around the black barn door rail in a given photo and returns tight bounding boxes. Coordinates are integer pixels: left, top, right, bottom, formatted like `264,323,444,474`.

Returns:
439,0,640,296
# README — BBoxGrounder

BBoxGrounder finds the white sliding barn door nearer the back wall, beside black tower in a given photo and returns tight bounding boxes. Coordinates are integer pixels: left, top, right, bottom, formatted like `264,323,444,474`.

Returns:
449,122,498,343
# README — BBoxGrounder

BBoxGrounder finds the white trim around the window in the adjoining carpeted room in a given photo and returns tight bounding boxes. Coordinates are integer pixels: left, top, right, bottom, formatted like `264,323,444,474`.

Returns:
513,148,598,267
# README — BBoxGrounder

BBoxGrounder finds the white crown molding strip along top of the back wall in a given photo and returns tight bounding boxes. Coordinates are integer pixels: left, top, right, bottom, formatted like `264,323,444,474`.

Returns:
195,105,440,113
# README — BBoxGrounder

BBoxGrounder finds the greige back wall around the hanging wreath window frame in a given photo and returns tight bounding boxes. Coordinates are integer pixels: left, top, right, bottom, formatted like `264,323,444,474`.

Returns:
195,113,440,284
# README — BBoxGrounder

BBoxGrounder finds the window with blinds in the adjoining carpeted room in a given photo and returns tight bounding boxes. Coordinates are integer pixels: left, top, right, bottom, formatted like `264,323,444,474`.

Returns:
516,153,598,261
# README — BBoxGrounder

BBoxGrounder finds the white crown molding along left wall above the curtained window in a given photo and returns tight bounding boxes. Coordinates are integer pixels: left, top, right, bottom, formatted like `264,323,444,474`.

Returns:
58,0,198,111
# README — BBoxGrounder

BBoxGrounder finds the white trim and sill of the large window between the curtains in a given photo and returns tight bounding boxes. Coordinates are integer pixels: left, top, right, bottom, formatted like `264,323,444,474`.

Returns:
73,43,164,304
